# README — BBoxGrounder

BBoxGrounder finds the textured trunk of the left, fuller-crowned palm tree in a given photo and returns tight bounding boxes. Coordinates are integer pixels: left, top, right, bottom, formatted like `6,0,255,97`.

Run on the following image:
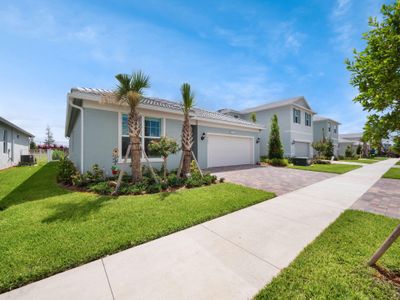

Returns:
128,109,142,183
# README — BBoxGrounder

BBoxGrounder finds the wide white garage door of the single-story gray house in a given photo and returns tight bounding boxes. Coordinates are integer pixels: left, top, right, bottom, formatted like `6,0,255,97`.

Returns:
207,134,254,168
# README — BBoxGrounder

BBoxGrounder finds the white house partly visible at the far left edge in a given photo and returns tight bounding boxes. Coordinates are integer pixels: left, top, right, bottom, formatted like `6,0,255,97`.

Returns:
0,117,33,170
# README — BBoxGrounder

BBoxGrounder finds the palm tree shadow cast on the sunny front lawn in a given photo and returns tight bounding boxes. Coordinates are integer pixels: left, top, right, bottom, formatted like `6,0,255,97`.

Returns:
42,196,115,223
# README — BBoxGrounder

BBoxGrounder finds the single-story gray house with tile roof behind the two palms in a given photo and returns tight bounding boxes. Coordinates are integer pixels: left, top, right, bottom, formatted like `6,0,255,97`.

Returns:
65,88,266,174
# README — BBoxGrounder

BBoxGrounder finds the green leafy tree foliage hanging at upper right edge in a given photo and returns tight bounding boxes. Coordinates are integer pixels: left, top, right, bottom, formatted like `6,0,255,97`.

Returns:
346,1,400,137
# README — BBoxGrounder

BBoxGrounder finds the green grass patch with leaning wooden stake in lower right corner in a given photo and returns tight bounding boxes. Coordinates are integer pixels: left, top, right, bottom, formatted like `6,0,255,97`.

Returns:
256,210,400,299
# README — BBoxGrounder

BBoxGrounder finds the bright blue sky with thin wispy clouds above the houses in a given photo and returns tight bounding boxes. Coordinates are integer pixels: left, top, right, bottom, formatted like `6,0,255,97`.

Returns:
0,0,388,141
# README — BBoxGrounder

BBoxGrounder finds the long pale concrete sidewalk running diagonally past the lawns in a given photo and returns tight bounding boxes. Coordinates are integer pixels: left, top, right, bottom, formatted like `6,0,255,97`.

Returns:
0,159,397,300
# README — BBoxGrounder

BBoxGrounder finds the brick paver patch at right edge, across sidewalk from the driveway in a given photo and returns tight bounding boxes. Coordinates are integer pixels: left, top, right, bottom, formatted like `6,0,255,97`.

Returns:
351,178,400,219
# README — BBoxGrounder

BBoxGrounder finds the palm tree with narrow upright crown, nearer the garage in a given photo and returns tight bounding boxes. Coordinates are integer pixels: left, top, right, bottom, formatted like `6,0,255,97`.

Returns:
179,83,194,176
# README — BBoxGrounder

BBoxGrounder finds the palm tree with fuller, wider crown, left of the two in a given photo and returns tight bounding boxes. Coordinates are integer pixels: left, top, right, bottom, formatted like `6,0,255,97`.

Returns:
115,71,150,182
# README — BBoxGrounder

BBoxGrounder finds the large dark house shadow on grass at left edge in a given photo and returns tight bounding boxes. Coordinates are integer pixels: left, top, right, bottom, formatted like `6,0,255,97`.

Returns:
0,162,70,210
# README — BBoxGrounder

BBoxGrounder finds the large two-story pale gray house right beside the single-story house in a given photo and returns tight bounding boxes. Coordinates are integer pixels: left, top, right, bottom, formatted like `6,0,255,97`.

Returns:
219,97,315,157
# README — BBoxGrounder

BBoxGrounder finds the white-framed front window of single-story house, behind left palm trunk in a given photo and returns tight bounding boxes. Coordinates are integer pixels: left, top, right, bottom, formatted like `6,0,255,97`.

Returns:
121,114,161,159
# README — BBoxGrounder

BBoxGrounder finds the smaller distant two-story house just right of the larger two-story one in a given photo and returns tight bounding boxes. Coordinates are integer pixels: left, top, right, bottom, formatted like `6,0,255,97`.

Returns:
313,116,340,156
